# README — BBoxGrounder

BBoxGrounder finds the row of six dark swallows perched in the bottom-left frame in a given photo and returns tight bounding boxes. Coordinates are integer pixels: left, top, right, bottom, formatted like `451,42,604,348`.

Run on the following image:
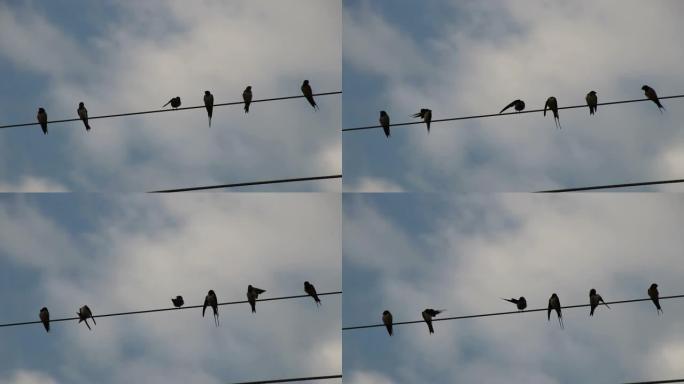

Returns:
38,281,321,332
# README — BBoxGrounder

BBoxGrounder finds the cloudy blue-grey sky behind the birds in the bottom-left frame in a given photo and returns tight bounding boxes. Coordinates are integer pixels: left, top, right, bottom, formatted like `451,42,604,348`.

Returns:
0,194,342,384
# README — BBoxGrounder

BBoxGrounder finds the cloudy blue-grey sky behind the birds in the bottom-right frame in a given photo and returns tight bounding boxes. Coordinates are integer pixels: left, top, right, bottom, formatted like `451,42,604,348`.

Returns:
342,194,684,384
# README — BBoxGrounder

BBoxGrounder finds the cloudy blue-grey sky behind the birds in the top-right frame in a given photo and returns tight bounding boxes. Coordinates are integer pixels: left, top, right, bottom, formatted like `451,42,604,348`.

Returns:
343,0,684,192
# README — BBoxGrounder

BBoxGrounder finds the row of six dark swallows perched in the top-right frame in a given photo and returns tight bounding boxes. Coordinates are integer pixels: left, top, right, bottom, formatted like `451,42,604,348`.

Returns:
379,85,665,138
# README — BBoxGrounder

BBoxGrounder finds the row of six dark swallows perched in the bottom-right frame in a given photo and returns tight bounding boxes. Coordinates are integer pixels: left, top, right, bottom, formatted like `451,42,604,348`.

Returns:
382,283,663,336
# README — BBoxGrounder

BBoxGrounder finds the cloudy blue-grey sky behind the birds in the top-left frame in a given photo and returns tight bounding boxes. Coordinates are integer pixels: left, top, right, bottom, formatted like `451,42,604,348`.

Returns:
0,0,342,191
